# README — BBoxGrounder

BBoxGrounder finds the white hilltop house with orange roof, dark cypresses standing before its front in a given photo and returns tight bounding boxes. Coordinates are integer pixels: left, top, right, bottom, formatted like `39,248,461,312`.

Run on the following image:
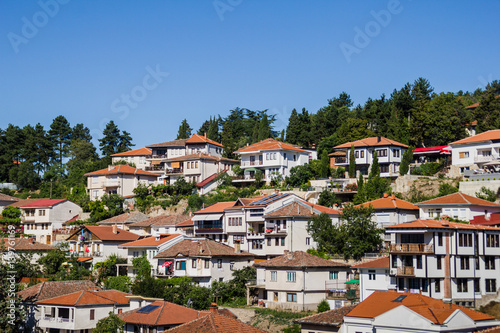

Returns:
333,136,408,178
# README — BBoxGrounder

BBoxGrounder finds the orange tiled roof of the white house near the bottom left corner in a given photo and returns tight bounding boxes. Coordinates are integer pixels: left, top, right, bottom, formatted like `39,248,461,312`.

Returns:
37,290,130,306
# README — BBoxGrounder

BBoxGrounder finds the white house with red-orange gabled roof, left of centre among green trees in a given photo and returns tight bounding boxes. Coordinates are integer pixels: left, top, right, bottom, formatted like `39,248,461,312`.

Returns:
67,225,139,263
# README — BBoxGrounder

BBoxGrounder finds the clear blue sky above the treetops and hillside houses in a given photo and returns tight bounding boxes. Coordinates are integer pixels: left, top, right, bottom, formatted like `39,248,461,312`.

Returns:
0,0,500,148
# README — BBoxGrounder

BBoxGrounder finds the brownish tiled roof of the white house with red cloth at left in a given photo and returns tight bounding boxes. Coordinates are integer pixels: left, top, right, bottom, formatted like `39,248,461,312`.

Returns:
155,239,254,259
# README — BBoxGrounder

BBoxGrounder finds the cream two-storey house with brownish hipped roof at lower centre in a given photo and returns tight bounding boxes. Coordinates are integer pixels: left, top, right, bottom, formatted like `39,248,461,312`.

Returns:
250,251,351,311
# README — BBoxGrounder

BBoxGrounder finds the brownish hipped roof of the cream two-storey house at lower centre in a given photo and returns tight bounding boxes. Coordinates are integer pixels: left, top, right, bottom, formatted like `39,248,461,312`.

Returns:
254,251,350,268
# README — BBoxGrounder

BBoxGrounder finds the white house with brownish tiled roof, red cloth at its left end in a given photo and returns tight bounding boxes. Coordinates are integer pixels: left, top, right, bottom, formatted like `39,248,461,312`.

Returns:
154,239,254,287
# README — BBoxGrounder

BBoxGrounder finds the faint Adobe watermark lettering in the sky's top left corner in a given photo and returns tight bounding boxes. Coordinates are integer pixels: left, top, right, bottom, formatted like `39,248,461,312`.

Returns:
7,0,70,53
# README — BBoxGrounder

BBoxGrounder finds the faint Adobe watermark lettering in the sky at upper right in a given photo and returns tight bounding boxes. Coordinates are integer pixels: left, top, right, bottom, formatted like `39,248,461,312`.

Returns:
339,0,403,64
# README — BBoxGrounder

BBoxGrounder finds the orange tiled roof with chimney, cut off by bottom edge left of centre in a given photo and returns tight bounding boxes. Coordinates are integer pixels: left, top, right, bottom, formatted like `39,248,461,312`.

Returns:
165,312,265,333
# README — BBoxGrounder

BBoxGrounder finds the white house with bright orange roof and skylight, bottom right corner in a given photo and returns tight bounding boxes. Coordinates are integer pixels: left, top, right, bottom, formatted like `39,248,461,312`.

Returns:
341,291,500,333
